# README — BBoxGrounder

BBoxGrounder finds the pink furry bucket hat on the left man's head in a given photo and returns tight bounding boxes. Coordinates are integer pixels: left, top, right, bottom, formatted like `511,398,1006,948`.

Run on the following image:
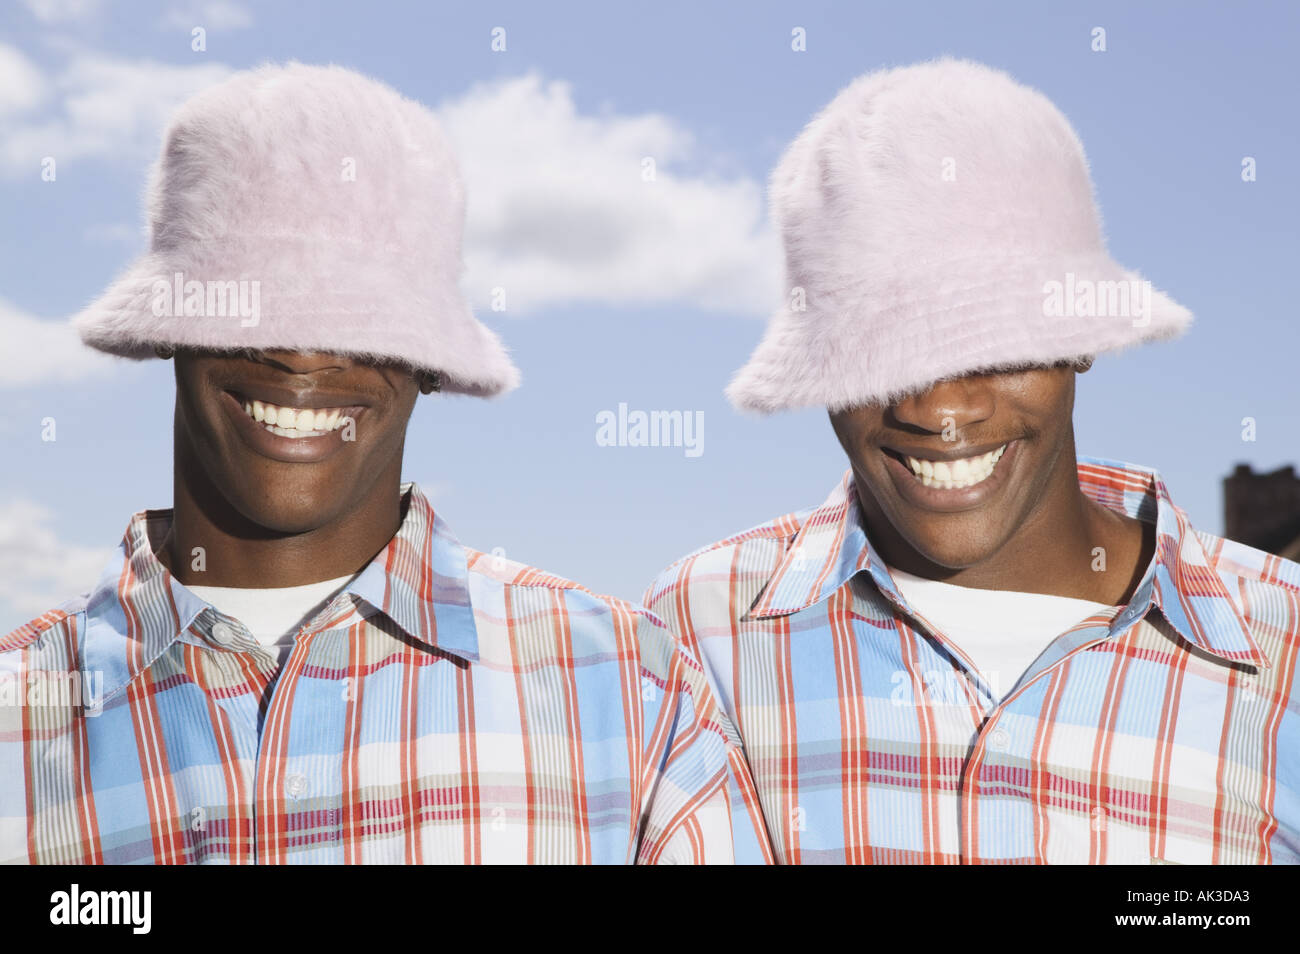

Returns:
74,62,519,395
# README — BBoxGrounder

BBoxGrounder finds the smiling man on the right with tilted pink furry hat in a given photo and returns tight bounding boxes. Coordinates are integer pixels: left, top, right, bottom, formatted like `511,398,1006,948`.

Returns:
645,60,1300,864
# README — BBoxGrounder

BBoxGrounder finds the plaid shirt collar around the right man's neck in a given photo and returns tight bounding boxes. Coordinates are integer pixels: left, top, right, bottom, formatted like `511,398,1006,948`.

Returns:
748,458,1269,667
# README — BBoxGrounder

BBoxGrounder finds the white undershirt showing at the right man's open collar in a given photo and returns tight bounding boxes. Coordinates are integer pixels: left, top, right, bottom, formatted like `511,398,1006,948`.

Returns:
888,567,1112,698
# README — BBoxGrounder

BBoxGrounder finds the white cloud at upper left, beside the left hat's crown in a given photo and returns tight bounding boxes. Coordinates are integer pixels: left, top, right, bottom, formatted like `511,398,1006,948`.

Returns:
0,52,230,177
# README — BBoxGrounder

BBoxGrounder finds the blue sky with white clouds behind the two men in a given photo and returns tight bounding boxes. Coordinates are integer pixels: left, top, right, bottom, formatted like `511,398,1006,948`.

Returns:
0,0,1300,632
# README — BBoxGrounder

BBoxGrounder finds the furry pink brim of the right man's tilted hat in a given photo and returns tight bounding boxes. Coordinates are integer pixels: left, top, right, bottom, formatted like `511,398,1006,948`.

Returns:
727,251,1192,413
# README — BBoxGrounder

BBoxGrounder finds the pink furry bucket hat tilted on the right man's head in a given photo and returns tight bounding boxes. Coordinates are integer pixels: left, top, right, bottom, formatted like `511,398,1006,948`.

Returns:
727,58,1192,412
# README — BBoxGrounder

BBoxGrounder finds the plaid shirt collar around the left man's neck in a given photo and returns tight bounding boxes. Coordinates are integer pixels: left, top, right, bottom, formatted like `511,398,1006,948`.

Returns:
82,483,478,699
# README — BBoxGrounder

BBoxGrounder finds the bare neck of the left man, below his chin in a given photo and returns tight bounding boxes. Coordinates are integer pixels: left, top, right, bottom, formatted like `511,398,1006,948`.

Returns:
157,455,404,589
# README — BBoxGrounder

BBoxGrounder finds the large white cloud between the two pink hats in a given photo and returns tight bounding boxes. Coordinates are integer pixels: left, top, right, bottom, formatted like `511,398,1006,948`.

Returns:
438,75,780,315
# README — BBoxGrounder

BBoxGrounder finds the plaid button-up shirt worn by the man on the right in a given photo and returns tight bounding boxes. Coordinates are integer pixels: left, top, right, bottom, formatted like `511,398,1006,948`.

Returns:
646,459,1300,864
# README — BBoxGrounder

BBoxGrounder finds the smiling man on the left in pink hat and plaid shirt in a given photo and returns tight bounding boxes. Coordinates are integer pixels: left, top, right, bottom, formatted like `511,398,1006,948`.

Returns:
0,64,732,864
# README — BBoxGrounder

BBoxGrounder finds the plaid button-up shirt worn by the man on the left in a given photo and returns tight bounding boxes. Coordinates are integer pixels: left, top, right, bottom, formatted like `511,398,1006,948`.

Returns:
0,486,732,863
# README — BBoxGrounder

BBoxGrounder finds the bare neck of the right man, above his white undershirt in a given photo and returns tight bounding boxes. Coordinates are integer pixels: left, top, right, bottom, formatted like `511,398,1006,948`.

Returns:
866,442,1156,606
